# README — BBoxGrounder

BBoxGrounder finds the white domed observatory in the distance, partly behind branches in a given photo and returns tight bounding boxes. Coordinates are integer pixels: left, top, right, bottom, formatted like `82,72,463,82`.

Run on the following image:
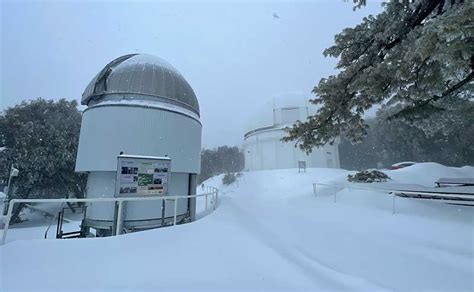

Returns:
243,94,339,171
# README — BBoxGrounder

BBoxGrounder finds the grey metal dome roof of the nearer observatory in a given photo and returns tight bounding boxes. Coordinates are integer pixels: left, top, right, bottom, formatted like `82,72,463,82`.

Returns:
81,54,199,115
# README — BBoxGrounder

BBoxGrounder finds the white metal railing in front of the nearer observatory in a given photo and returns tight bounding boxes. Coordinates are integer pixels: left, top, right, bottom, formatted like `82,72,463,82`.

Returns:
1,187,219,245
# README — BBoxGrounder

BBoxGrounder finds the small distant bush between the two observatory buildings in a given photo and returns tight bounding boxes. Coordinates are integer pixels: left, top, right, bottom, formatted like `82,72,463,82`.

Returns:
199,146,245,182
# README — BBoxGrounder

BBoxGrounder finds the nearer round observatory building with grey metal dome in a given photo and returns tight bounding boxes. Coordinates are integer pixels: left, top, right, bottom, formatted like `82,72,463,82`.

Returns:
76,54,202,236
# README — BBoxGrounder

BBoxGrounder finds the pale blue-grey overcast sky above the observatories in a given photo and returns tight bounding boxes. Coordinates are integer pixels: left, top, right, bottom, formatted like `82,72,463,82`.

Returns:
0,0,381,147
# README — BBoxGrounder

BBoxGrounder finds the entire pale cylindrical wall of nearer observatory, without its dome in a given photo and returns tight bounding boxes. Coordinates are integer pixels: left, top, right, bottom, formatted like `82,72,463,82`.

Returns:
76,104,201,221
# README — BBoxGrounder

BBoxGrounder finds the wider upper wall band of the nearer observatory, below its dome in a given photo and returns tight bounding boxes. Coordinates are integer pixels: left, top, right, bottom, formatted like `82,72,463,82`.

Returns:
76,105,202,173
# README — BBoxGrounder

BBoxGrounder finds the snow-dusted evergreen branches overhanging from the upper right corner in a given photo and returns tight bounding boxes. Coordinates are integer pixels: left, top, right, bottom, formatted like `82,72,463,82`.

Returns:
283,0,474,152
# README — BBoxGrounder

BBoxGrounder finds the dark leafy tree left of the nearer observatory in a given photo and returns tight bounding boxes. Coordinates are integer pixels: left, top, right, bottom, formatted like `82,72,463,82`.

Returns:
0,98,86,219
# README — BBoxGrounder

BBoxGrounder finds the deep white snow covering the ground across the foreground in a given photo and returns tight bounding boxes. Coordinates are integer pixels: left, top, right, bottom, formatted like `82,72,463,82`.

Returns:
0,163,474,291
